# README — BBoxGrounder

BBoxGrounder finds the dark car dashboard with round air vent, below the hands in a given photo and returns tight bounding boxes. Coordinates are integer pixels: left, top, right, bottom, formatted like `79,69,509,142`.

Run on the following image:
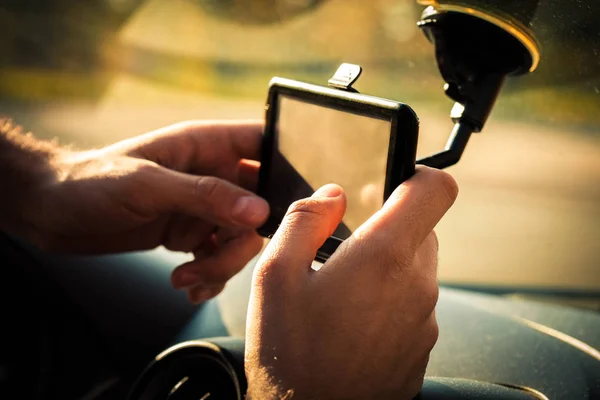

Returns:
0,237,600,400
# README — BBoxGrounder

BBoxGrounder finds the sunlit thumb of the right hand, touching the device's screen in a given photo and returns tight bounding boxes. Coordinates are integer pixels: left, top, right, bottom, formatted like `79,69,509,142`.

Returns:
261,184,346,277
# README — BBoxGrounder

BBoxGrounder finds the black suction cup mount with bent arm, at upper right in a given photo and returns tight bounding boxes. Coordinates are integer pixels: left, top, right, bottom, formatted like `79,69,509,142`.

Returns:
417,2,540,169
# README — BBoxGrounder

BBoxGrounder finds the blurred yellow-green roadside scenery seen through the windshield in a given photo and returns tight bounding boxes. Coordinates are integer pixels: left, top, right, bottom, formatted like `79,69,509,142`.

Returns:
0,0,600,307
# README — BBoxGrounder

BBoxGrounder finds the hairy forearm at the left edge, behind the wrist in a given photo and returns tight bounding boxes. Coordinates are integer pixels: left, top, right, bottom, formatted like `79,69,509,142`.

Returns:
0,119,61,234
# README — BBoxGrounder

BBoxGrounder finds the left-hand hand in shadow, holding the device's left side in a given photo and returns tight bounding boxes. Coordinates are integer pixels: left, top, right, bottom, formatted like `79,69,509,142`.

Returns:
8,122,269,302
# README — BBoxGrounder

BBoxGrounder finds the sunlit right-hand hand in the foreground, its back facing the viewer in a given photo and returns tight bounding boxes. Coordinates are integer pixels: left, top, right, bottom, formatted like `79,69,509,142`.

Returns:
246,167,458,400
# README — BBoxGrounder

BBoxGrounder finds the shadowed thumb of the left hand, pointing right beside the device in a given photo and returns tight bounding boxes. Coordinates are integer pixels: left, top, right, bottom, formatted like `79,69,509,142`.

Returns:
154,168,269,228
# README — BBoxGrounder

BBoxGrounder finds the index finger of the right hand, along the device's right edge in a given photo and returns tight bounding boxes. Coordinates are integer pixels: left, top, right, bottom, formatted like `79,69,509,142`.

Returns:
352,166,458,252
